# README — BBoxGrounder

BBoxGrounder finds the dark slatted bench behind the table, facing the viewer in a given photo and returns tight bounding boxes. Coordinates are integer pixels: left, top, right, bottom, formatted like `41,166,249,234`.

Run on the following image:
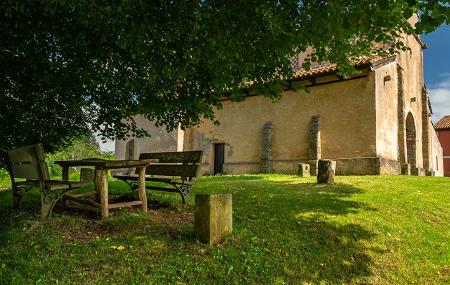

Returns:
113,151,203,204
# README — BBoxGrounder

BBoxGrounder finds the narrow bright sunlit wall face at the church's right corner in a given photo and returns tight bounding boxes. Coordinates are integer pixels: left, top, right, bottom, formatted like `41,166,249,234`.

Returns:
375,62,399,160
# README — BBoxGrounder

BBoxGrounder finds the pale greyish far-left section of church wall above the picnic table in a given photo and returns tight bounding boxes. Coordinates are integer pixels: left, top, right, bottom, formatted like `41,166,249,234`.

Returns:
115,116,182,159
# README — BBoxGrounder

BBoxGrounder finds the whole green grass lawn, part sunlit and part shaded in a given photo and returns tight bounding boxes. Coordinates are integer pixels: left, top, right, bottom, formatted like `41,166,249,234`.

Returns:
0,175,450,284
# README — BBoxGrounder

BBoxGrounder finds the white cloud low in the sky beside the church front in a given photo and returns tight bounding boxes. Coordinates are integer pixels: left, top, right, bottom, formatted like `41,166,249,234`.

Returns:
428,74,450,123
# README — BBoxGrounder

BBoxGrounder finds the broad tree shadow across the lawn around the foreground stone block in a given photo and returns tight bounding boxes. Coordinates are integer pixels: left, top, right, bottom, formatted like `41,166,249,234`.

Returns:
0,176,380,284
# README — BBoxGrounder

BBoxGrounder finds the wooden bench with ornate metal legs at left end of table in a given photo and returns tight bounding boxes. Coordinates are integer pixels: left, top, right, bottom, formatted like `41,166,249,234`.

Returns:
7,144,88,218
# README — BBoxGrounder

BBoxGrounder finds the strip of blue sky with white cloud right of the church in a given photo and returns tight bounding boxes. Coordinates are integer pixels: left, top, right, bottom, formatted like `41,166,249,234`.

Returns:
422,26,450,123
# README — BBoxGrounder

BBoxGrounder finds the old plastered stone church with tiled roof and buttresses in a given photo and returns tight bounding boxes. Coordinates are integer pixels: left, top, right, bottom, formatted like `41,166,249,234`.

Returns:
116,32,443,175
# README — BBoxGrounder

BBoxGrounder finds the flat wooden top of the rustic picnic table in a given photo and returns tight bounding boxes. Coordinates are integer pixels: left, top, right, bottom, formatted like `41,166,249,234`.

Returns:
55,158,158,169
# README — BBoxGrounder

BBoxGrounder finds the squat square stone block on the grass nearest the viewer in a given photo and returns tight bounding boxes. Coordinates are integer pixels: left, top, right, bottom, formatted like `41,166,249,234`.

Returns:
195,194,233,245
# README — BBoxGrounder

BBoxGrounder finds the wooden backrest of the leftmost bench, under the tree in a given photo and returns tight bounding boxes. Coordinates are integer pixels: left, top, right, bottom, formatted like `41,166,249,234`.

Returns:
8,144,49,183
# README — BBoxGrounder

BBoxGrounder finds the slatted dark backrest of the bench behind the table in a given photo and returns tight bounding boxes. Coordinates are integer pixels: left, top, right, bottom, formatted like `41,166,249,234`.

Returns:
139,151,203,178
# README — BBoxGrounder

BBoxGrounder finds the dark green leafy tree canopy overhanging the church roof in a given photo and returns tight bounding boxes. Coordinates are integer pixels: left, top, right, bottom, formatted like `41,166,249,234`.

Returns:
0,0,450,153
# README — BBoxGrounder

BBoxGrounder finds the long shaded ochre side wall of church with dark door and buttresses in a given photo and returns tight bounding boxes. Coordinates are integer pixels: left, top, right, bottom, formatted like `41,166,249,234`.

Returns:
184,73,376,174
